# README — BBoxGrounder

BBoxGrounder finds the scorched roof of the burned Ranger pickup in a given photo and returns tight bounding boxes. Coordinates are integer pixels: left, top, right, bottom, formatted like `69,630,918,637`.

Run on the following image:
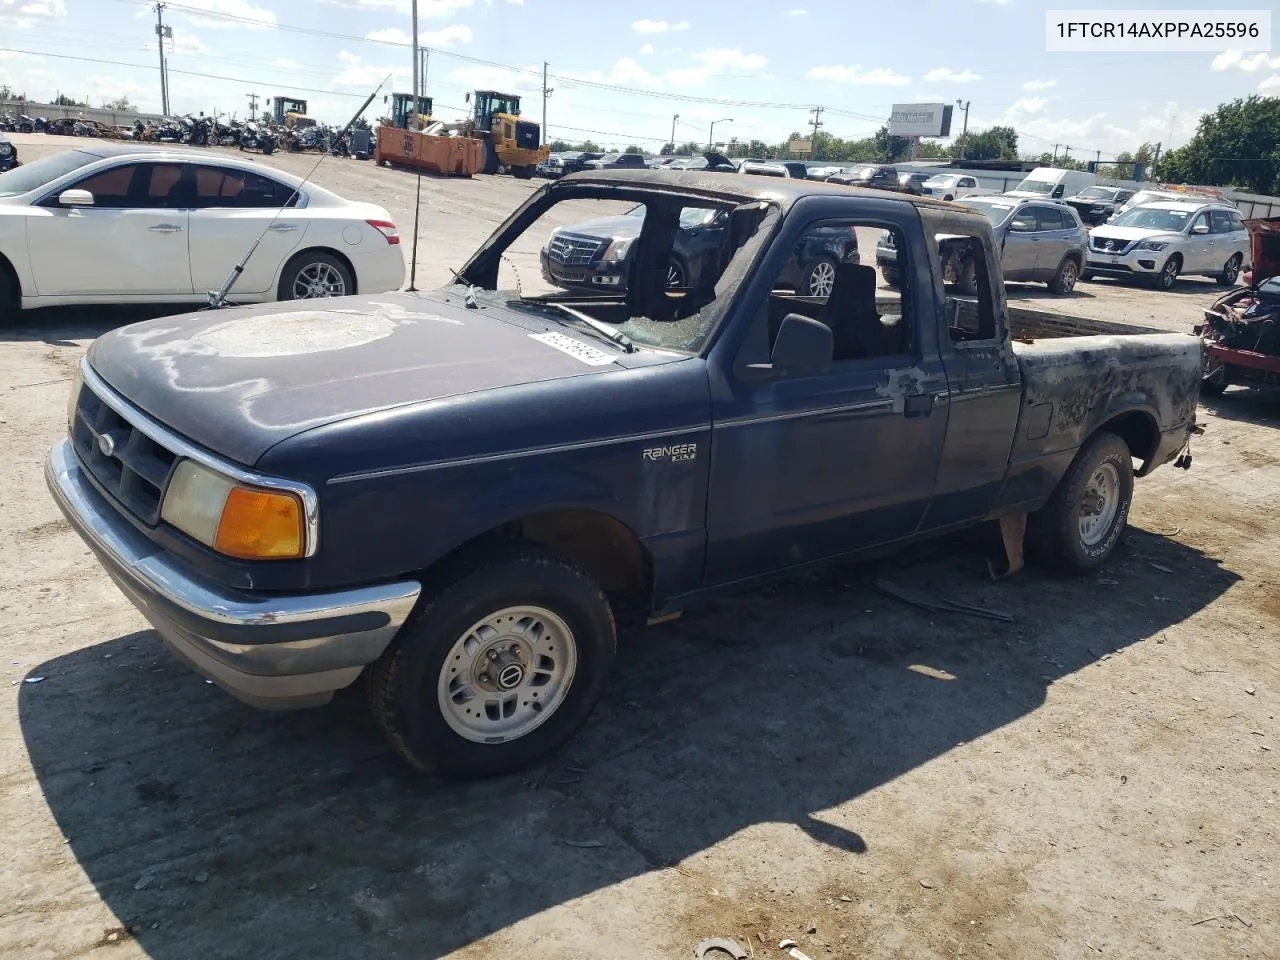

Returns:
557,169,968,214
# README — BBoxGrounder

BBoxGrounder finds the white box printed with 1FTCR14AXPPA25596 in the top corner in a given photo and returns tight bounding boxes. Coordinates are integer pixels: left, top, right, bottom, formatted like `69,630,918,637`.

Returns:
1044,10,1271,54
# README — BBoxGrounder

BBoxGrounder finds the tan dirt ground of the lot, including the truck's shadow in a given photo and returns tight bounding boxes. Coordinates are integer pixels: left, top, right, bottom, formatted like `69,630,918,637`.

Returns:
0,136,1280,960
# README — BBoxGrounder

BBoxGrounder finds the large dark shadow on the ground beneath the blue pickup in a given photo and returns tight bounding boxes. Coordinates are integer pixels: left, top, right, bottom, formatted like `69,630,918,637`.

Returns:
19,531,1238,960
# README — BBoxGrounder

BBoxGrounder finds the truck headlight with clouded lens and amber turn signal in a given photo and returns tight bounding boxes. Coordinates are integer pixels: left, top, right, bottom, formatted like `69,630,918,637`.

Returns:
160,460,306,559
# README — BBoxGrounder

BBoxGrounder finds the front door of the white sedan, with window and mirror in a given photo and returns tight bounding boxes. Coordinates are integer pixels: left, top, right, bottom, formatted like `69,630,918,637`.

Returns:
27,164,192,301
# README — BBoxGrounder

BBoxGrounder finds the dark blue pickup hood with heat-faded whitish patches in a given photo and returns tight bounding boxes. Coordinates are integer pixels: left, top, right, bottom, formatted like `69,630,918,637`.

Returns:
88,289,641,466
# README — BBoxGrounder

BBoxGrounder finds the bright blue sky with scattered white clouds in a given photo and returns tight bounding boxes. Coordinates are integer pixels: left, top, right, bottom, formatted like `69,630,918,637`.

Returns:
0,0,1280,159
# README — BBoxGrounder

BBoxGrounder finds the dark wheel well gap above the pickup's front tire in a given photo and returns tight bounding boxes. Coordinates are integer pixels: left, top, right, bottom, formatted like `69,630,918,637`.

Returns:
454,509,653,603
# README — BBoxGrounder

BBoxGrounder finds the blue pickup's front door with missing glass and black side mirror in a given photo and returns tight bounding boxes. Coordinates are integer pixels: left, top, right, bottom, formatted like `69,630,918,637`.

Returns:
705,197,946,586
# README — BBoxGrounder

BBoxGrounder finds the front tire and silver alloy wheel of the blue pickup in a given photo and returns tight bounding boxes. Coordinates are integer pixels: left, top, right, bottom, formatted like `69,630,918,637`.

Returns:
366,544,617,778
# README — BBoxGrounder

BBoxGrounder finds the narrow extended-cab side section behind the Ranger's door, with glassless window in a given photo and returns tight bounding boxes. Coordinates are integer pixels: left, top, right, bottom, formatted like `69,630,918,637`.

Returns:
922,211,1018,530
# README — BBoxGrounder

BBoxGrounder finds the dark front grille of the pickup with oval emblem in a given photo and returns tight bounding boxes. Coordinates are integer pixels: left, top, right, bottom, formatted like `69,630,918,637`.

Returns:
72,384,178,525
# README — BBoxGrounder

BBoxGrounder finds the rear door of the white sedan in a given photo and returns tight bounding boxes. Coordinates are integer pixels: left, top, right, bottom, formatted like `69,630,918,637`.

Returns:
191,164,307,298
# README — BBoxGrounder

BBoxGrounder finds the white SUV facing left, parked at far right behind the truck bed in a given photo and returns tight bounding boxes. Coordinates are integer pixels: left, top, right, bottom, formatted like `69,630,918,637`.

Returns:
1084,198,1249,291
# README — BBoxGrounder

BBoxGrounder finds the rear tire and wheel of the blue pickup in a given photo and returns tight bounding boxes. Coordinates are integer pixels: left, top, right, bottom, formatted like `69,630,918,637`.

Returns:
1029,430,1133,573
